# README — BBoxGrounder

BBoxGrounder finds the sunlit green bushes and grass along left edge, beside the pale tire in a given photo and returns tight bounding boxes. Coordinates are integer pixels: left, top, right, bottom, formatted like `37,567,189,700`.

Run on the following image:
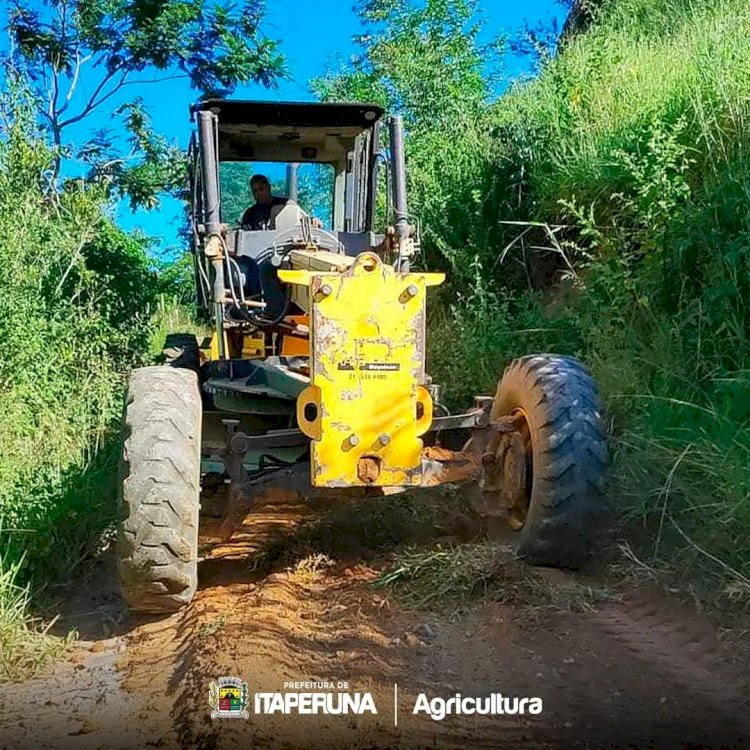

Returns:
0,82,163,672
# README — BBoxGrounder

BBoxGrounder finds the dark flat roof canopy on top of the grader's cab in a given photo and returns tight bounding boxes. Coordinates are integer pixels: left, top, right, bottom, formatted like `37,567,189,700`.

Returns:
190,99,383,163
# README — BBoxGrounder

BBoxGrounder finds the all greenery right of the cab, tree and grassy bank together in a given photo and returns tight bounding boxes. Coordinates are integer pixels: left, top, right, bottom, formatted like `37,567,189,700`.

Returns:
324,0,750,590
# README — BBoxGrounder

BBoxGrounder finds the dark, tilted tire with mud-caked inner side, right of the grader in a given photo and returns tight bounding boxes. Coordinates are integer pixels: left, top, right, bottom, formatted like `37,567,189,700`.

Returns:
491,354,607,568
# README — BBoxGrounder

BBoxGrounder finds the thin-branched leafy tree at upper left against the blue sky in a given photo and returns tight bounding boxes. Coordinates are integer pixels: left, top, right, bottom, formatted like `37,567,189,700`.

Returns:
9,0,285,205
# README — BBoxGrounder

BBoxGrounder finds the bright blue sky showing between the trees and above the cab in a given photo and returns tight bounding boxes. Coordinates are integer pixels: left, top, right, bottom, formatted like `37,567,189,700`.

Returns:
0,0,565,250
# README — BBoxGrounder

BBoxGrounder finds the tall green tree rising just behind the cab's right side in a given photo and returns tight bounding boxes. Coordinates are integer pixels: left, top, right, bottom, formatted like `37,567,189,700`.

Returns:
312,0,508,278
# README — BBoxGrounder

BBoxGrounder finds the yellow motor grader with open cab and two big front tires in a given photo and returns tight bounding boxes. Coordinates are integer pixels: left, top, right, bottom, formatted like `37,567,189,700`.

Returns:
117,99,607,612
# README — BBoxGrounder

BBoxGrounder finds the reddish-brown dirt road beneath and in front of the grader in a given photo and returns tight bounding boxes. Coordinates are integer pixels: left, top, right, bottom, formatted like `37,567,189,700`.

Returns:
0,484,750,750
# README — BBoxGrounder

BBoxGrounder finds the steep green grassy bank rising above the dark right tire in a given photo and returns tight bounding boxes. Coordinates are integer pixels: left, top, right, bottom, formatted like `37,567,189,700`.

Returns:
429,0,750,595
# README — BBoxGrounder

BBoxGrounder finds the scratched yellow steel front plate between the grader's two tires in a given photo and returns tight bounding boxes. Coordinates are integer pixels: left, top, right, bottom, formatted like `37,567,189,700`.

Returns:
278,253,445,487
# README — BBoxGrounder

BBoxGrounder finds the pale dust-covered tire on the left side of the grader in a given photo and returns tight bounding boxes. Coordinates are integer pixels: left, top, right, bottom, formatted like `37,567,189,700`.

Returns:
117,367,202,612
